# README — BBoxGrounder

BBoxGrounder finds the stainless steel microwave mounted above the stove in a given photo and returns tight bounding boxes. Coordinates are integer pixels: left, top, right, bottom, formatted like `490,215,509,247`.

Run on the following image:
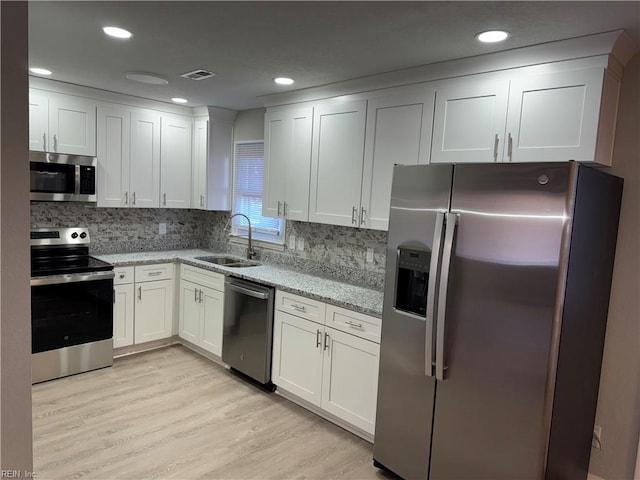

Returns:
29,152,98,202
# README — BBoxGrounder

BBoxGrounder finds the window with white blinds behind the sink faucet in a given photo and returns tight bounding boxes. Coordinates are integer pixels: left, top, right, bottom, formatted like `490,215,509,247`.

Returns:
232,141,284,244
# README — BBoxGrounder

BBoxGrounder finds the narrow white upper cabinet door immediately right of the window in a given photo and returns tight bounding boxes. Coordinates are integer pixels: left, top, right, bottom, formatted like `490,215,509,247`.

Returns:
262,112,291,217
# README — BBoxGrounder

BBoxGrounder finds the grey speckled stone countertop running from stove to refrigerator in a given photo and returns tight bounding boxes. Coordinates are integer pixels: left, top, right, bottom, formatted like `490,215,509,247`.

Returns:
93,250,383,318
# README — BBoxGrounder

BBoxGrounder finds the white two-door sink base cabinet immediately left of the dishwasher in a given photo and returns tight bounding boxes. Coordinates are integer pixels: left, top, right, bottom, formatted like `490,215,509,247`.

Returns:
178,265,224,356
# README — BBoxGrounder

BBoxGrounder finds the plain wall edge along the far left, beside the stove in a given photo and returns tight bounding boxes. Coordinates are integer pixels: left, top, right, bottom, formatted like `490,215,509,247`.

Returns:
0,2,33,475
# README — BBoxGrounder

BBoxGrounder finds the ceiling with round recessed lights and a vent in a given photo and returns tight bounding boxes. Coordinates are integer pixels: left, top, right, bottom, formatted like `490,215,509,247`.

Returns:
29,1,640,110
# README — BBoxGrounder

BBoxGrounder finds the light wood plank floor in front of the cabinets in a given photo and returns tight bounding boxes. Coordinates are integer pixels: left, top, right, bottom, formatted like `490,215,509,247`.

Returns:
33,346,390,480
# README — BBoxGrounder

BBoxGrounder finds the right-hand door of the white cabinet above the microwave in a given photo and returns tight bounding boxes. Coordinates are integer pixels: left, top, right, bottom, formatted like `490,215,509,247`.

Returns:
47,94,96,157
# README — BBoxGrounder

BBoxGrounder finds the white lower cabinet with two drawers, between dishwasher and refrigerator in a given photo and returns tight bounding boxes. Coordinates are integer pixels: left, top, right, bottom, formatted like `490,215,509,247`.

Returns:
271,291,380,435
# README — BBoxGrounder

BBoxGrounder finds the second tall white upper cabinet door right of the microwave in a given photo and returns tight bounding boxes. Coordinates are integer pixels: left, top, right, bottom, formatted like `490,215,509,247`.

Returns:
129,110,160,208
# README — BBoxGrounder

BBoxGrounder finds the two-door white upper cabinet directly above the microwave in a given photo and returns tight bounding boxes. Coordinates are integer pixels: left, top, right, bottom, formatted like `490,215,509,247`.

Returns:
29,90,96,157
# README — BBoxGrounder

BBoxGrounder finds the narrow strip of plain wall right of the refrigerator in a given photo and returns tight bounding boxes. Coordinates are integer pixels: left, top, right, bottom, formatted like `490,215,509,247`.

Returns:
590,55,640,480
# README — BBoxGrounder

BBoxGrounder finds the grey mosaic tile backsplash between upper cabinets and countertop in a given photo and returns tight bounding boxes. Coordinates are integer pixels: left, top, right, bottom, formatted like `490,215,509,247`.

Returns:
31,202,387,288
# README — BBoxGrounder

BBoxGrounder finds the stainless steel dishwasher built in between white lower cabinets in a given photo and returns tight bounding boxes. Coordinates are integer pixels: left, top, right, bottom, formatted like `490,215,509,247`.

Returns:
222,277,275,391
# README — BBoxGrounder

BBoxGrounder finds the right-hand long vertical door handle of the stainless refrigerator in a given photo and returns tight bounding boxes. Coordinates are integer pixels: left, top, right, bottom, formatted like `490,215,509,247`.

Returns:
436,213,458,381
